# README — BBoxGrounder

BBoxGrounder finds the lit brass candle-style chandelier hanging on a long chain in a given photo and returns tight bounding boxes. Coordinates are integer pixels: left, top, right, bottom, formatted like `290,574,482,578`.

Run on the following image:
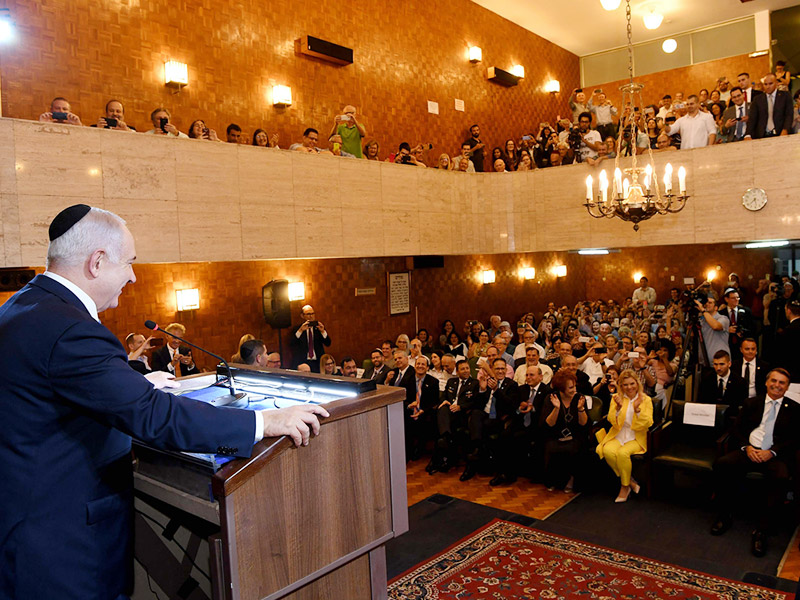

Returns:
584,0,689,231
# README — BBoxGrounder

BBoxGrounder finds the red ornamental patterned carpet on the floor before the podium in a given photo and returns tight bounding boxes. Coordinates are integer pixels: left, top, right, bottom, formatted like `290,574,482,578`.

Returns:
389,519,789,600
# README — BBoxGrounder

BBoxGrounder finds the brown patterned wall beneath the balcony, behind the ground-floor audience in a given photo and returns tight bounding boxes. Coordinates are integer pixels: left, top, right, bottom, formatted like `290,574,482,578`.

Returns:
0,244,772,368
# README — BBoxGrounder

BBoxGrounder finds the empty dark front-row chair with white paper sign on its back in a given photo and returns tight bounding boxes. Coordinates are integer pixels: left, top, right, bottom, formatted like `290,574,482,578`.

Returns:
648,398,729,496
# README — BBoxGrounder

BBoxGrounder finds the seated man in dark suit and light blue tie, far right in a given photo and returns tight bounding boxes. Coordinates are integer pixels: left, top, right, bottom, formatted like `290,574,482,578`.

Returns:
711,368,800,556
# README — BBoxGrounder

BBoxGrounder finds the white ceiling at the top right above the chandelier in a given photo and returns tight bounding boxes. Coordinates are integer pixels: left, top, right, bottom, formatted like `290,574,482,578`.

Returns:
473,0,798,56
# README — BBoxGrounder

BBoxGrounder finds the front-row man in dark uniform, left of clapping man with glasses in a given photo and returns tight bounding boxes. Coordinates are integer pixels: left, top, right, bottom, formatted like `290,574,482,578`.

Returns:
425,360,482,475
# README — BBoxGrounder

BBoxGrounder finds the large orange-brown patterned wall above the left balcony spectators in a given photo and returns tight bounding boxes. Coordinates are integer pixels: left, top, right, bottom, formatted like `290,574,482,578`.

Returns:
0,0,579,162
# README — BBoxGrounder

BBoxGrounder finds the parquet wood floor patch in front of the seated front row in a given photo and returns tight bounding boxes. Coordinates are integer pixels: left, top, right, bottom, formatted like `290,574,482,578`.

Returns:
406,457,577,519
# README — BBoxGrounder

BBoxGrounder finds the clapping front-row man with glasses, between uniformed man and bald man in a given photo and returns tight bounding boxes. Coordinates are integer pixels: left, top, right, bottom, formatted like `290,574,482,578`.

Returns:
459,358,519,481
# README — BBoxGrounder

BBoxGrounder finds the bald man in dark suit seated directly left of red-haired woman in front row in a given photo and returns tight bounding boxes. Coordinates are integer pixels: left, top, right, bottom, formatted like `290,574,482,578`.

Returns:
489,365,550,486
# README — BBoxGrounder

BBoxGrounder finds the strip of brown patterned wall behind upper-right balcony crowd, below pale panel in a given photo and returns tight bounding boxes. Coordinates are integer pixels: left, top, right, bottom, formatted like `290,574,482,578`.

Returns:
587,54,770,107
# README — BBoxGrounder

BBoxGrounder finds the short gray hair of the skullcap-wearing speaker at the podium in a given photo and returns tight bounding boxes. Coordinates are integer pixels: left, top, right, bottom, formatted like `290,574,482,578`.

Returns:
47,207,125,269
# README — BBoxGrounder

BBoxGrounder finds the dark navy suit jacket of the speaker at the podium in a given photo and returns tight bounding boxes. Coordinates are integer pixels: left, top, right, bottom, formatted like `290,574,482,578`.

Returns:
0,275,255,600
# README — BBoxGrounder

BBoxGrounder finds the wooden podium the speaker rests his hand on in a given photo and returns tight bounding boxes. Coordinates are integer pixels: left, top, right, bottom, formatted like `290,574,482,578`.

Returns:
134,370,408,600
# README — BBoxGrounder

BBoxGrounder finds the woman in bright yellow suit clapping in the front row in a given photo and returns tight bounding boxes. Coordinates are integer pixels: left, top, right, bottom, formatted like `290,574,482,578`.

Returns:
597,369,653,502
